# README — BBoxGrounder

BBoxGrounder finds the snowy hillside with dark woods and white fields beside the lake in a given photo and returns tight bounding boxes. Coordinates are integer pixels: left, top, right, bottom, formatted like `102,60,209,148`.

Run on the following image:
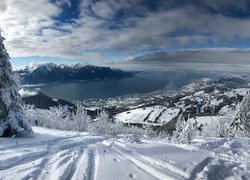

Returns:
74,77,250,132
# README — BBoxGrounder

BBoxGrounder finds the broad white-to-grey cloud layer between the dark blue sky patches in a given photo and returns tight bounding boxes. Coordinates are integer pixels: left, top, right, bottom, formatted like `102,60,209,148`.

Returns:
0,0,250,60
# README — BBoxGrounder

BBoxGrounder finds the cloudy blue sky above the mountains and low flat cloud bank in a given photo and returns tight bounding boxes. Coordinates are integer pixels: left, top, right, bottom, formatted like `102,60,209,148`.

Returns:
0,0,250,66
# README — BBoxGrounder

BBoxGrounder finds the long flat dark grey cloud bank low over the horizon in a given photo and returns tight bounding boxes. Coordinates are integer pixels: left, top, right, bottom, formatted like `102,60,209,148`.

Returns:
129,48,250,65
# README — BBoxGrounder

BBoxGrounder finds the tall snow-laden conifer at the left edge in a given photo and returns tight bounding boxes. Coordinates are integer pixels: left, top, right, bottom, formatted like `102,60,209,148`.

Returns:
0,29,33,136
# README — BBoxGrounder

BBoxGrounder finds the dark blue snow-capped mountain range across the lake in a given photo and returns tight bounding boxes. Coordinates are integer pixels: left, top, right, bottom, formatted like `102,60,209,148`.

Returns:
16,63,133,84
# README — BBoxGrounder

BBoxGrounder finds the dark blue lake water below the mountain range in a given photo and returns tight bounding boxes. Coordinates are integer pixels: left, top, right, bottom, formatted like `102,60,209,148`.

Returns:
30,71,211,101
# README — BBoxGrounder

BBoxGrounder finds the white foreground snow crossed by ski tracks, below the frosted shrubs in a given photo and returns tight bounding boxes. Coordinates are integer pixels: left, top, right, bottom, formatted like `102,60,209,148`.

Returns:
0,127,250,180
